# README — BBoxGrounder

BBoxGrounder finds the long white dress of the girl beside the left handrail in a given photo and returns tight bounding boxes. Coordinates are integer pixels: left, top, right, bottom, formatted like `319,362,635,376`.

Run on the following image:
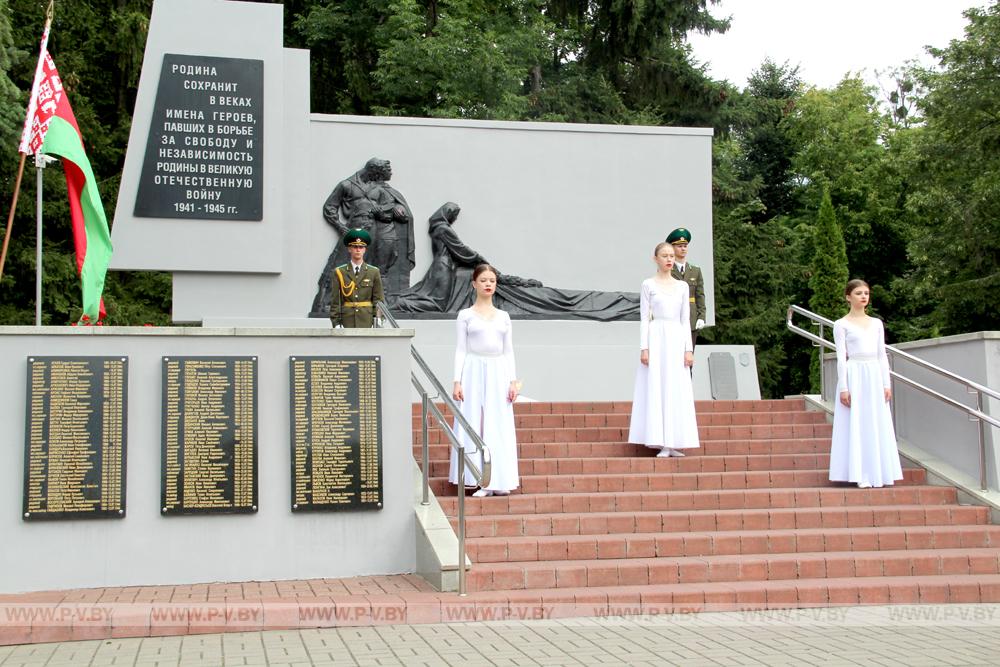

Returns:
448,308,520,491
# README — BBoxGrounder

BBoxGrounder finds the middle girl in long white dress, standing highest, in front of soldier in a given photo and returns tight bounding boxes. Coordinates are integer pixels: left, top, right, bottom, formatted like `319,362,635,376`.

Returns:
628,243,698,457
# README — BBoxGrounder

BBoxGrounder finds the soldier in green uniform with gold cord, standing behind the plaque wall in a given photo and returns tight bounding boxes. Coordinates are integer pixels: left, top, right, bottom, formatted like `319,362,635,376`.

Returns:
330,229,385,329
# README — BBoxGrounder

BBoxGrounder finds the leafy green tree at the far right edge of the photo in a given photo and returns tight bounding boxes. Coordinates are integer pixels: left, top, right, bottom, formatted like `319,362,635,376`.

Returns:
907,2,1000,334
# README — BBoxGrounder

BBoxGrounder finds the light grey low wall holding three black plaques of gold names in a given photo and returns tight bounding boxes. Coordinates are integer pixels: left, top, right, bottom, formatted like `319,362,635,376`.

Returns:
0,327,416,592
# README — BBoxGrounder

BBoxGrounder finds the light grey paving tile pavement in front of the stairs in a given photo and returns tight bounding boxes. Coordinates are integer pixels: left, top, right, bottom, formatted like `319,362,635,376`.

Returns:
0,604,1000,667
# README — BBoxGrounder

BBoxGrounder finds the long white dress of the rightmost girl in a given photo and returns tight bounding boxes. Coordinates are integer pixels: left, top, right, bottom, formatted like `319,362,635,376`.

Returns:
830,318,903,487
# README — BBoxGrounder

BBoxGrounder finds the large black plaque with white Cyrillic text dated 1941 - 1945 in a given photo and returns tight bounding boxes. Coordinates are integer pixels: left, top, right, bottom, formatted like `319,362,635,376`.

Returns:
135,53,264,220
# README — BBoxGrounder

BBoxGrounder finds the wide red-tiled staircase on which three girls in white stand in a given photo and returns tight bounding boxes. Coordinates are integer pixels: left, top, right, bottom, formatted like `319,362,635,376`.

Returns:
414,400,1000,615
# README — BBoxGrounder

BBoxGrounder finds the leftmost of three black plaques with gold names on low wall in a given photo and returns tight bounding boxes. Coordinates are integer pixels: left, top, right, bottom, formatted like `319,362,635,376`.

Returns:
22,357,128,521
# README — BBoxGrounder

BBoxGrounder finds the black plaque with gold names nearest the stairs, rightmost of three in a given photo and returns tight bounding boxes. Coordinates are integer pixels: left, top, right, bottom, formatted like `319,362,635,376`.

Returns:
289,357,382,512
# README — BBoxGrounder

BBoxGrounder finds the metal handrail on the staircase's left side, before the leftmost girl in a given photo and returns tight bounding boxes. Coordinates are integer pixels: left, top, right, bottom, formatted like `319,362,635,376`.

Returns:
375,301,493,595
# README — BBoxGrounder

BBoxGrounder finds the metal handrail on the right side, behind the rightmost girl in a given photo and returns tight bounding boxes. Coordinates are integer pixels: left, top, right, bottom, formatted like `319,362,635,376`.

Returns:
785,304,1000,491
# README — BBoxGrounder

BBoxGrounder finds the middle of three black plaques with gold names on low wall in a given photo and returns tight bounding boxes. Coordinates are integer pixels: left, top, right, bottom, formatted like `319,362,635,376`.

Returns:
160,357,257,515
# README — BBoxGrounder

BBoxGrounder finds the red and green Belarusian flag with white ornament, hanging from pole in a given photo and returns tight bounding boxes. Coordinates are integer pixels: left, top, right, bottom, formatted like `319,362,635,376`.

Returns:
20,24,111,324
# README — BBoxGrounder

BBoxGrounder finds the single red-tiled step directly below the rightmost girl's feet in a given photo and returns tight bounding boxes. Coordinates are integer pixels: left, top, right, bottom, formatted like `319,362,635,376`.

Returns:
438,486,957,516
